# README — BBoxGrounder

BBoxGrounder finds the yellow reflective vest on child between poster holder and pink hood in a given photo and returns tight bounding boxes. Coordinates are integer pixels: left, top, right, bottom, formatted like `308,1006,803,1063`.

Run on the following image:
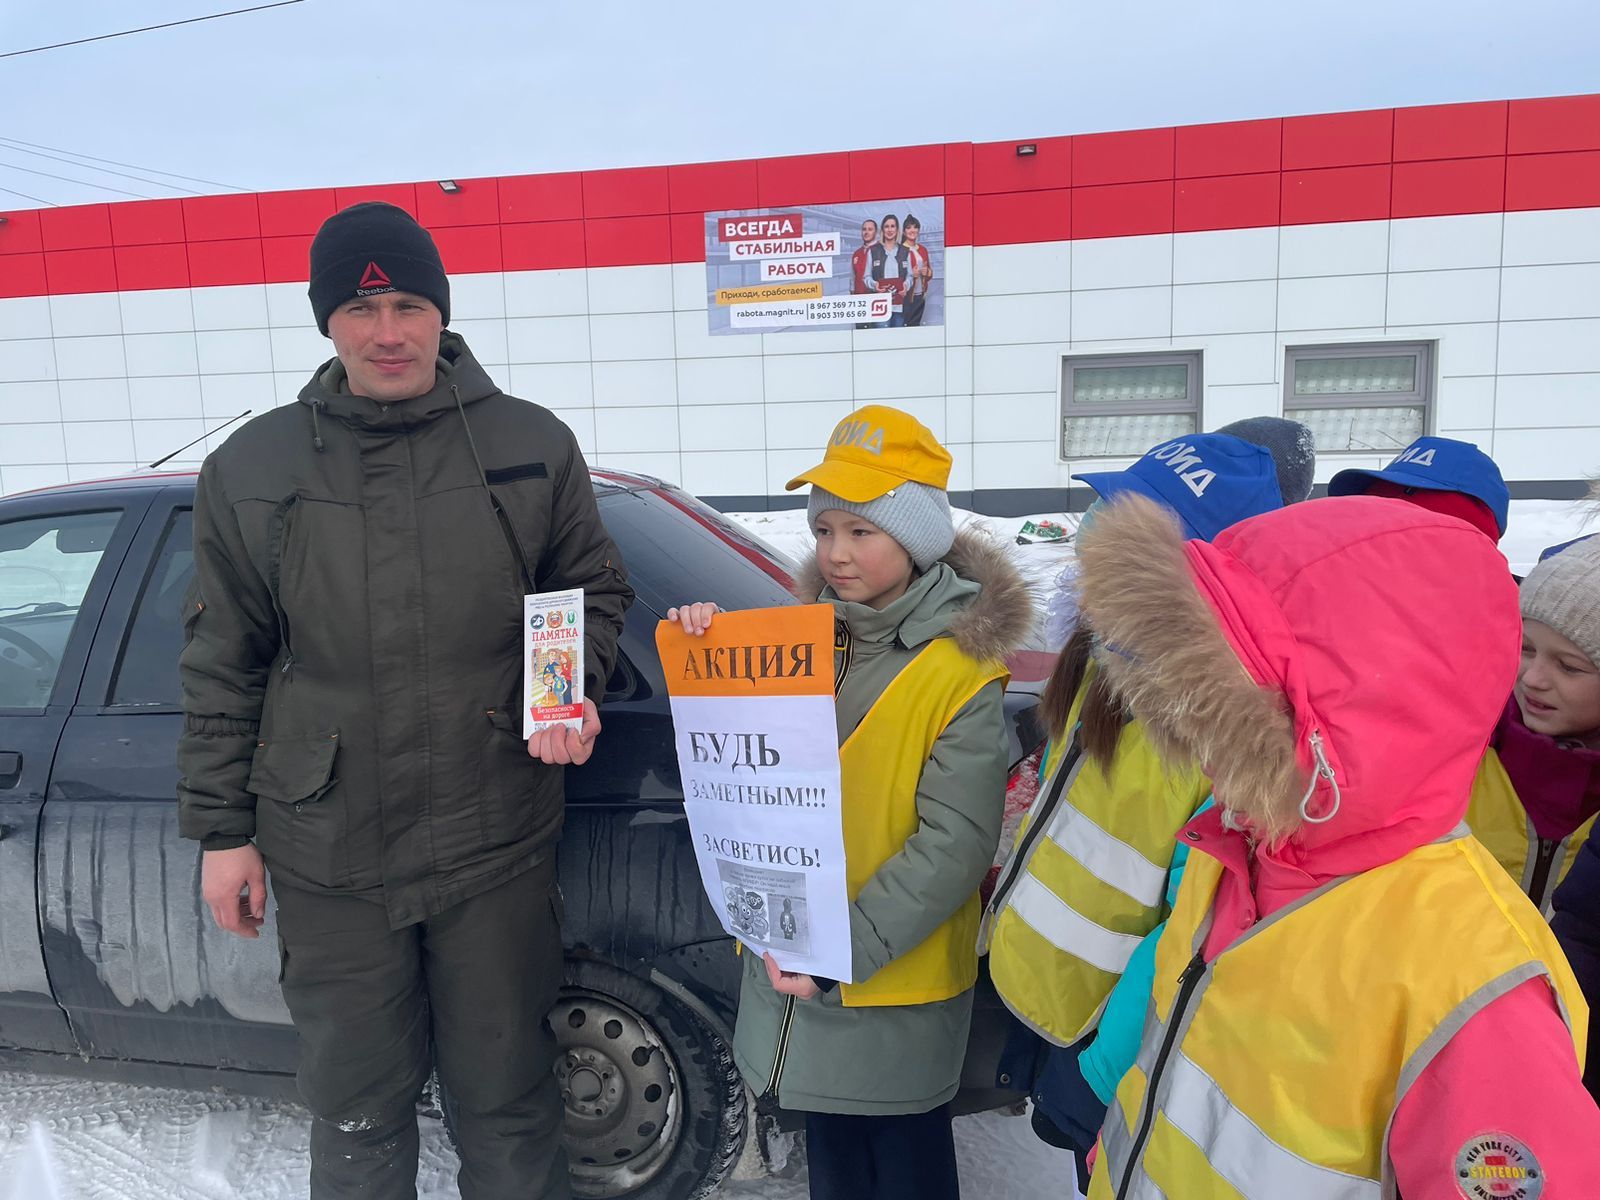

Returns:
979,667,1211,1046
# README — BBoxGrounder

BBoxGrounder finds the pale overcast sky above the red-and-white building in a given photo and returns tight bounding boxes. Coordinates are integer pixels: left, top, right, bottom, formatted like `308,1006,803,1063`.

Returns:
0,0,1600,208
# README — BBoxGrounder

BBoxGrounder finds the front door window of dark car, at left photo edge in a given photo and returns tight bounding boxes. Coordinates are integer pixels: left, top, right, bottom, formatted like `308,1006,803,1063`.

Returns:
0,510,122,710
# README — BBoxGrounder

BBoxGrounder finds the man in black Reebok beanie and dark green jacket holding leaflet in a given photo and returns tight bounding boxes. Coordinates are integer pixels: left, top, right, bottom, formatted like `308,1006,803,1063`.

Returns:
178,203,634,1200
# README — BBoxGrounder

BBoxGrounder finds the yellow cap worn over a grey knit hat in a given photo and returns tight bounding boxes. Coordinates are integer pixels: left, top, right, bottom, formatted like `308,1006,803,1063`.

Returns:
784,405,950,504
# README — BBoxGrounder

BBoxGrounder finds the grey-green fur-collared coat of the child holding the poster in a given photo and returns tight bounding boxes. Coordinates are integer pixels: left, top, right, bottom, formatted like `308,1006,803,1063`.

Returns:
733,533,1034,1115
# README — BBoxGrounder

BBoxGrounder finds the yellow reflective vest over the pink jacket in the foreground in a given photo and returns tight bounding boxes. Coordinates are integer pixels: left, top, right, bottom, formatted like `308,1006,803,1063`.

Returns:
1090,827,1589,1200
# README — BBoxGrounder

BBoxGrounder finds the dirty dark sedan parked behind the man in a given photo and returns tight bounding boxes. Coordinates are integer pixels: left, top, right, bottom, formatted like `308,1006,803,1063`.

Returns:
0,472,1040,1198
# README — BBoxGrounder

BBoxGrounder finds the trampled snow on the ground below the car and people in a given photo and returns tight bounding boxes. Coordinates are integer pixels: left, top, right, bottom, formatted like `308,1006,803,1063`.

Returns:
0,1072,1074,1200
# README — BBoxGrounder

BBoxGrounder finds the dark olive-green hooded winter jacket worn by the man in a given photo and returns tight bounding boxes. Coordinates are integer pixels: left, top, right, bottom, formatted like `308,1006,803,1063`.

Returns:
178,331,634,928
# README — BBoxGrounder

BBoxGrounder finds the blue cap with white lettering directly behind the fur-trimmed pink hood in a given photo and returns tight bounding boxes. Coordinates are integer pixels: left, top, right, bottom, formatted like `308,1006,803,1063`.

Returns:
1074,434,1283,541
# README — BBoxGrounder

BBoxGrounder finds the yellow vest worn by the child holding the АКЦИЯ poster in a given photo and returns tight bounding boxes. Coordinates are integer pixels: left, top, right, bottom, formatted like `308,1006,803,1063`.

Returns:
838,637,1008,1008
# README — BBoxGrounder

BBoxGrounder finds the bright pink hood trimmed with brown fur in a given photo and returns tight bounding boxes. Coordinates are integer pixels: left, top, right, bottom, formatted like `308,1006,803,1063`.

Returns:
1078,496,1520,878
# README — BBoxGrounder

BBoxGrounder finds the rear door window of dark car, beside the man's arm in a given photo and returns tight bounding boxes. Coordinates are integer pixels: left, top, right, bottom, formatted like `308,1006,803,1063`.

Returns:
109,509,195,709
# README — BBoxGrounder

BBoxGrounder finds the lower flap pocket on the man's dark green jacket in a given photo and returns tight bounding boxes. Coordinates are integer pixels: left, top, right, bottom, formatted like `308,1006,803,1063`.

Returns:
246,730,347,888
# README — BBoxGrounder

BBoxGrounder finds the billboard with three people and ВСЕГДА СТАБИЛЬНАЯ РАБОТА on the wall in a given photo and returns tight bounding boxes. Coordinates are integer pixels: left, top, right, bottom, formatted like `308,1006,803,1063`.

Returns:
706,197,944,334
